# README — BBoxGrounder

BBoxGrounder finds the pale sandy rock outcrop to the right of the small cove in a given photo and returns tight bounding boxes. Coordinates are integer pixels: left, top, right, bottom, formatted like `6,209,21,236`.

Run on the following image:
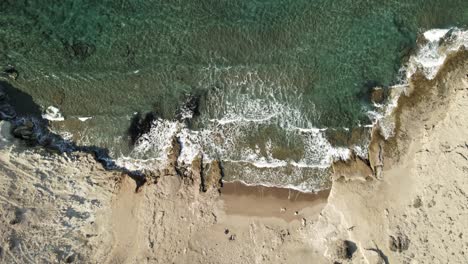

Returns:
314,48,468,264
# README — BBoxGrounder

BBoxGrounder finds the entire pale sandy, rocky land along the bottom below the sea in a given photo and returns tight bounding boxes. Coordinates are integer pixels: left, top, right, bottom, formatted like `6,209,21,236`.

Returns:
0,50,468,263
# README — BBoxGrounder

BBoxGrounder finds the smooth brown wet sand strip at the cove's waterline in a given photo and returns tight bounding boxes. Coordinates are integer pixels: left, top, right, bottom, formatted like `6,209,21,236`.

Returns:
221,182,330,222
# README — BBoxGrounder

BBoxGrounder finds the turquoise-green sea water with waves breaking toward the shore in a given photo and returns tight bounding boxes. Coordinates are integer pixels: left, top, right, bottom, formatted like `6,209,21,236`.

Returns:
0,0,468,190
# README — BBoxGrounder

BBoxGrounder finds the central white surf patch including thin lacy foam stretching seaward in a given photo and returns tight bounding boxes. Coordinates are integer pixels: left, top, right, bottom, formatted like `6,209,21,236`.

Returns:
117,69,368,191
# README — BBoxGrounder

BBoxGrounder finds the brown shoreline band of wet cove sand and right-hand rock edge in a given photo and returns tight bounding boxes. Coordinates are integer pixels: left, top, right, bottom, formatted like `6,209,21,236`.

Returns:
220,29,468,231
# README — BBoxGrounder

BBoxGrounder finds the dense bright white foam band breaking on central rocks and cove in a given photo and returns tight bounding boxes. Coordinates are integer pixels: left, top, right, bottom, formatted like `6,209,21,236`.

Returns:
117,97,350,191
